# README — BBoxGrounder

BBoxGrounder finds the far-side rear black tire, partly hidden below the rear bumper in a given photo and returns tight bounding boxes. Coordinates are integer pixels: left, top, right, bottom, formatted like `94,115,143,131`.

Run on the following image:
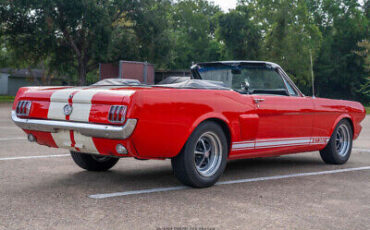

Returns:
71,151,119,171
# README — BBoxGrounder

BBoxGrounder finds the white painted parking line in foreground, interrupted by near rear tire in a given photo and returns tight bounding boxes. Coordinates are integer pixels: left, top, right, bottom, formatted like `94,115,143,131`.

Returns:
89,166,370,199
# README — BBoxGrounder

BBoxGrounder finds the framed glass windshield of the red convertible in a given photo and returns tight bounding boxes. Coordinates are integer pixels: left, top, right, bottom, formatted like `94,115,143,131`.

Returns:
198,63,286,95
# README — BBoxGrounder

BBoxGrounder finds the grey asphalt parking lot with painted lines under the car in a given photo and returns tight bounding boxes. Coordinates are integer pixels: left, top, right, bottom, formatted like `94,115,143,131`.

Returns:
0,103,370,230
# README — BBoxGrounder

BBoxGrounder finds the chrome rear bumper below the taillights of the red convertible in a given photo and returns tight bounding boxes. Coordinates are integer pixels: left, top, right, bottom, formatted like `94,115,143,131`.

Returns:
12,110,137,139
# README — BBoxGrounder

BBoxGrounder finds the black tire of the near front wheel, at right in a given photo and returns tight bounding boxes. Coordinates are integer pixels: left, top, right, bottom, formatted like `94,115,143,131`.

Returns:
320,120,353,164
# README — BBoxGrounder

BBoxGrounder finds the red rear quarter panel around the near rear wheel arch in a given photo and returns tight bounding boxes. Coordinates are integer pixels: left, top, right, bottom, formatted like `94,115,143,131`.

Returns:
128,89,253,158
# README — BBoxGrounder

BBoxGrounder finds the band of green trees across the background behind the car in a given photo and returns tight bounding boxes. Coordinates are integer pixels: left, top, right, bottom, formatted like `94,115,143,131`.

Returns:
0,0,370,104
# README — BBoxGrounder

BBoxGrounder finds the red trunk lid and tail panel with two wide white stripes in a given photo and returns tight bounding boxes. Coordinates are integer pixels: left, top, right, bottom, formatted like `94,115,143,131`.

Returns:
19,86,135,123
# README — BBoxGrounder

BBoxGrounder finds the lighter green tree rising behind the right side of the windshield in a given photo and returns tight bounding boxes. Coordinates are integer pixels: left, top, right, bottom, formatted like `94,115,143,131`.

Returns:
251,0,322,94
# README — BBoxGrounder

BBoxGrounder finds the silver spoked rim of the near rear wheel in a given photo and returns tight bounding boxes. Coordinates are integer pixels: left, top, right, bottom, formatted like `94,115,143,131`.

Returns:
194,132,222,177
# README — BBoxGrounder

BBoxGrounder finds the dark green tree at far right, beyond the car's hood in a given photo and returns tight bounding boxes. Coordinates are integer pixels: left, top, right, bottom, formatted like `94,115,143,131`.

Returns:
311,0,369,102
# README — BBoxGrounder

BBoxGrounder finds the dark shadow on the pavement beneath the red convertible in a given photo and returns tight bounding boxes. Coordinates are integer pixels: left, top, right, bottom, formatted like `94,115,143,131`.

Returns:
28,156,326,193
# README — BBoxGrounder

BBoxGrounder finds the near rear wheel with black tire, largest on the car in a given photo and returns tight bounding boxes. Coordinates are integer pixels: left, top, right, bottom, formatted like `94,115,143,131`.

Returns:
171,121,229,188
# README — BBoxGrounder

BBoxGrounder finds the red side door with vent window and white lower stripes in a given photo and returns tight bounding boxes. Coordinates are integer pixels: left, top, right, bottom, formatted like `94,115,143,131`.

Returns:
252,69,314,149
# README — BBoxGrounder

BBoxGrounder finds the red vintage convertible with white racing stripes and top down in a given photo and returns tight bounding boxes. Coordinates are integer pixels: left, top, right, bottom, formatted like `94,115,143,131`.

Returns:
12,61,365,187
